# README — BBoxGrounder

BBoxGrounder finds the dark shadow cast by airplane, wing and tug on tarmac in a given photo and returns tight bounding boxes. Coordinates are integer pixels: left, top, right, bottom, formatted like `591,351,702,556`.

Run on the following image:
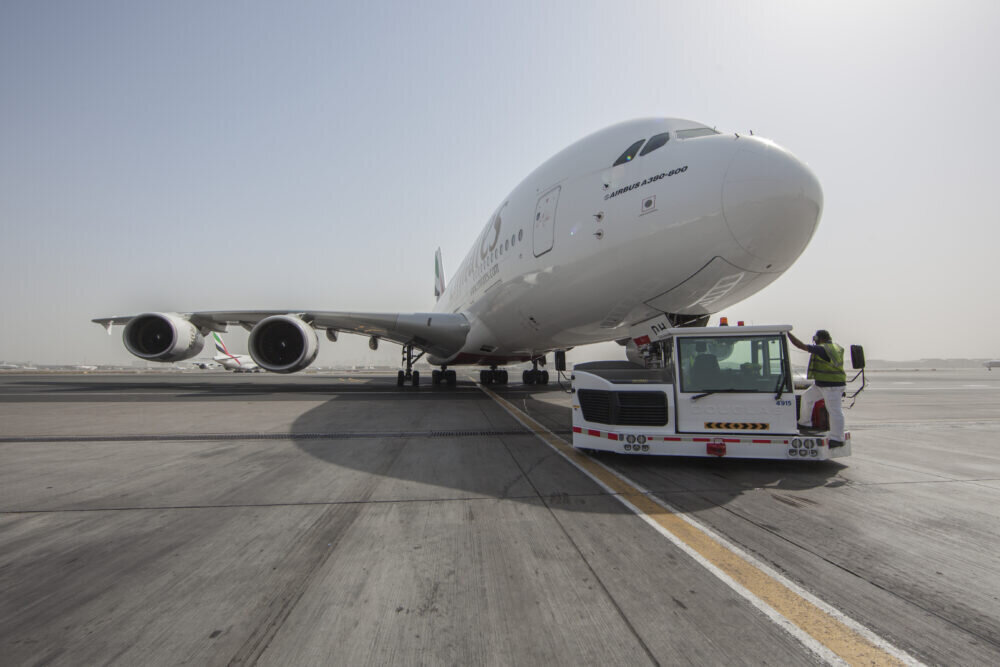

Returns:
0,374,847,512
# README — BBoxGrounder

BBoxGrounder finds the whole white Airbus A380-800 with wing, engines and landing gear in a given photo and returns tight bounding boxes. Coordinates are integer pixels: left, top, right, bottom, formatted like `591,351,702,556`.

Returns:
93,118,823,386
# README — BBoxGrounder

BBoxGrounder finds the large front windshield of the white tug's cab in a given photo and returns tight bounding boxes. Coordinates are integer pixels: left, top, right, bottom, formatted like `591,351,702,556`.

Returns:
677,334,791,394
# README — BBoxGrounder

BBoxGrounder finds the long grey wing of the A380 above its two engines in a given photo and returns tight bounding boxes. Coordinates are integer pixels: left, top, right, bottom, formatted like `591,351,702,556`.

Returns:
93,310,469,361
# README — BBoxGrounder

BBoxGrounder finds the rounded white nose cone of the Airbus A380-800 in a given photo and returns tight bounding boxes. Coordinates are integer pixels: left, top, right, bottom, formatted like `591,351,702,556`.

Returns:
722,137,823,271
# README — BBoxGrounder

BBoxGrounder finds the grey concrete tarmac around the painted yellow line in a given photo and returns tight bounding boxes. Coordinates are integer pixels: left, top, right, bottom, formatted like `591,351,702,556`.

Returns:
0,369,1000,665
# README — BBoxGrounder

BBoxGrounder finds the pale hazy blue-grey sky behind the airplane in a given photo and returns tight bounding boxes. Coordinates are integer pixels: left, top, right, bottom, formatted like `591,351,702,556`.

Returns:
0,0,1000,364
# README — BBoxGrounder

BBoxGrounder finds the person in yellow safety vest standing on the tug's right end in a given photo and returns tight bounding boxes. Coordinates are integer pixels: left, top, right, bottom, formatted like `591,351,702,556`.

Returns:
788,329,847,448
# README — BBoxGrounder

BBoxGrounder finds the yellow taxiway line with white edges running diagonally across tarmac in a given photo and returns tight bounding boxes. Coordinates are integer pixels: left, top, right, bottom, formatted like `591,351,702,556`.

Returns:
480,385,921,665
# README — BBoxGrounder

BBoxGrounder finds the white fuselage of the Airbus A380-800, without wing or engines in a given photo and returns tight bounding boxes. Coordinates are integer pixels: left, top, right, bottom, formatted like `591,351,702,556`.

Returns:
431,118,822,364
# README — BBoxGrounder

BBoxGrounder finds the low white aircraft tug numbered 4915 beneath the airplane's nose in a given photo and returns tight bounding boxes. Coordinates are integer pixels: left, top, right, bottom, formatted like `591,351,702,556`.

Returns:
572,318,864,461
